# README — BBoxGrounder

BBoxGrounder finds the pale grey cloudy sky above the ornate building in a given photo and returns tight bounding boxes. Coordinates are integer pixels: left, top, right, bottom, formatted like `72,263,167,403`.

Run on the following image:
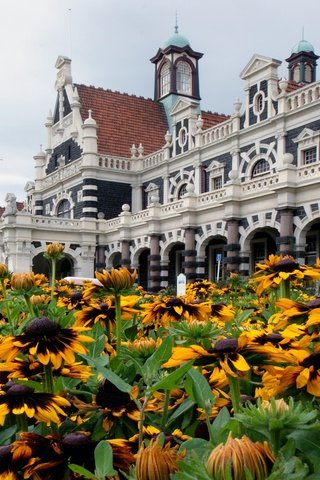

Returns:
0,0,320,206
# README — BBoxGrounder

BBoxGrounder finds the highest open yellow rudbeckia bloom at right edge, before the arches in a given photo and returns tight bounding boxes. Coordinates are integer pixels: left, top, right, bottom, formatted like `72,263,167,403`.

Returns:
250,255,320,295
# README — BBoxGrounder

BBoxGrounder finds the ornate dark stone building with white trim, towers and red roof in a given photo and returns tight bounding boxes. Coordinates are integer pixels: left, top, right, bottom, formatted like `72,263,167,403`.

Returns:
0,30,320,291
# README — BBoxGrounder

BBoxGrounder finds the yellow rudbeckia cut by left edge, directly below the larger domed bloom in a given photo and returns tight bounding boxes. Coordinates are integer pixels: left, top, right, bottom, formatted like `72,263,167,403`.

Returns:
0,382,70,425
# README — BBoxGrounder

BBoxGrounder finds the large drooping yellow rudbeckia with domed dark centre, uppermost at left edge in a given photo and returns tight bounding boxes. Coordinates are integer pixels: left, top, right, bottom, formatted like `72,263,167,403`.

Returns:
0,317,94,368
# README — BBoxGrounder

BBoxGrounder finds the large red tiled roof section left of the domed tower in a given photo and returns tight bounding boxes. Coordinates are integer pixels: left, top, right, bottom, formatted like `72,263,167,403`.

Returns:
75,84,168,157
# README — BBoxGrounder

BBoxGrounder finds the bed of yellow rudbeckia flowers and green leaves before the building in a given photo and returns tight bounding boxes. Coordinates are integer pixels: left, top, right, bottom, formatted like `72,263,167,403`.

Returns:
0,244,320,480
